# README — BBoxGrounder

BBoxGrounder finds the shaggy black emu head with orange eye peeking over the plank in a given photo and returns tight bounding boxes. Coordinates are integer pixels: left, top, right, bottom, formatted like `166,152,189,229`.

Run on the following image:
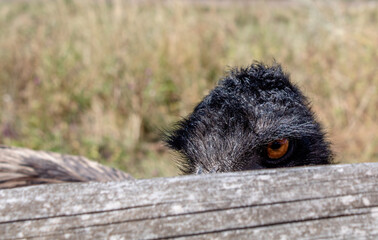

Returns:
165,63,332,174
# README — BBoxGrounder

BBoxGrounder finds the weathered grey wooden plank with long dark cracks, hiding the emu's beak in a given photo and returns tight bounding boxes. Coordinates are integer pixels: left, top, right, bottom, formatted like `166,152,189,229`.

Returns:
0,163,378,239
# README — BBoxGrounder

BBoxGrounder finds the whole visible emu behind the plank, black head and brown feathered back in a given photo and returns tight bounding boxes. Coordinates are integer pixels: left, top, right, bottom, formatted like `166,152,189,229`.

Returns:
0,62,332,188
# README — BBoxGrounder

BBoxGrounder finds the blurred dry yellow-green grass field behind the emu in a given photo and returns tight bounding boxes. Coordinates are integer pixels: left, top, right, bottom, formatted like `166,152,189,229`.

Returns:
0,0,378,177
